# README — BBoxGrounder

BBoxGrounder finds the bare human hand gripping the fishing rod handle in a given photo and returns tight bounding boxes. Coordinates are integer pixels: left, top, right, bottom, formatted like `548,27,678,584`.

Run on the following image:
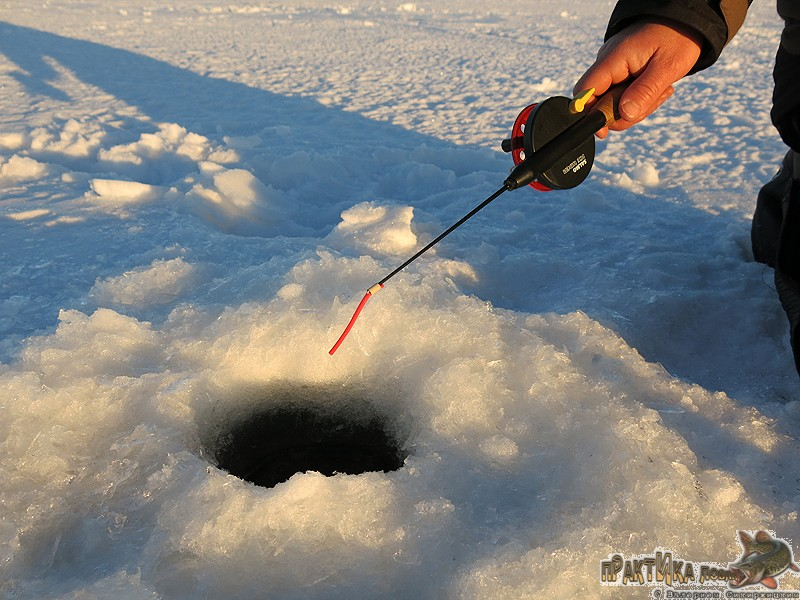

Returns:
575,20,703,138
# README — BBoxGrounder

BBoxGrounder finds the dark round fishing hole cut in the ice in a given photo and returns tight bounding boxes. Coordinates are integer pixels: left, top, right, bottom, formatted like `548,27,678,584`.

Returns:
208,386,408,488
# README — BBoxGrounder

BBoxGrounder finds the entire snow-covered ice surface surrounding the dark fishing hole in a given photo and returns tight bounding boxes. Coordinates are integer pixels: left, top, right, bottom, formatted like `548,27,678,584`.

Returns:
0,0,800,600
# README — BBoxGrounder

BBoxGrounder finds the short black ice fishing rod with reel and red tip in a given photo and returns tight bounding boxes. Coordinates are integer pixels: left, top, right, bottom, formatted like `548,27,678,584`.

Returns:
328,83,627,355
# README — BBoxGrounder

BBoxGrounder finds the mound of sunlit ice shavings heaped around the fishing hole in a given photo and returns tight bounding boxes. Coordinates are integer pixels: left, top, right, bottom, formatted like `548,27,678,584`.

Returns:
2,247,791,598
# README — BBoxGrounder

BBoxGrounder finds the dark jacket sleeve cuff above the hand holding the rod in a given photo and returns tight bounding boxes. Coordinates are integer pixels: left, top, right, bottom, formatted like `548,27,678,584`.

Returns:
606,0,752,73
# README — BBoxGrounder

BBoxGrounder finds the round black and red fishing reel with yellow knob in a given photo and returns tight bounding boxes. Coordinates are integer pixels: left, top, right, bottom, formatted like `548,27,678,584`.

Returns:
502,90,595,192
